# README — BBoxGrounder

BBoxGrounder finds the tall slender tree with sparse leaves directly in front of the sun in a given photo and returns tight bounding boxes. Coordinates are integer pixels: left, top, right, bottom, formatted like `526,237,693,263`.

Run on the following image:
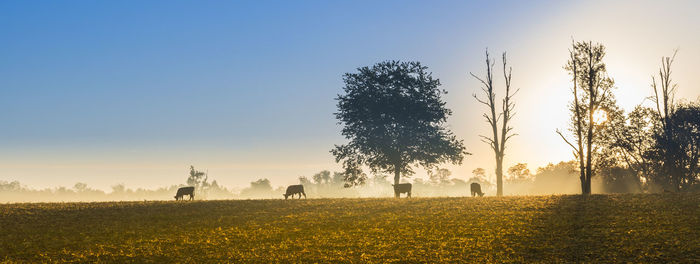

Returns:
557,41,615,195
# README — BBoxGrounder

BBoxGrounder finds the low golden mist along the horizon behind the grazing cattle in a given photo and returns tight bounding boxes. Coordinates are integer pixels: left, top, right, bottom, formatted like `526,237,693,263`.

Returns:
0,161,642,203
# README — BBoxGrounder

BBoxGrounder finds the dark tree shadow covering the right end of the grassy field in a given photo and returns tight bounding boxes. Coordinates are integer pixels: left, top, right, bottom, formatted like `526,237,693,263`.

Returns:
520,194,700,263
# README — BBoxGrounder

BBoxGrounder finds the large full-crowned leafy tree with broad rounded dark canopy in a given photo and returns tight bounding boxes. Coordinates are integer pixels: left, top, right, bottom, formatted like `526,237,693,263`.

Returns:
331,61,468,197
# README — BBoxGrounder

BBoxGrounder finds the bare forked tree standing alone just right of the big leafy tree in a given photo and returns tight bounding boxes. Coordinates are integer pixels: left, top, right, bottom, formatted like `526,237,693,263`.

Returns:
469,49,518,196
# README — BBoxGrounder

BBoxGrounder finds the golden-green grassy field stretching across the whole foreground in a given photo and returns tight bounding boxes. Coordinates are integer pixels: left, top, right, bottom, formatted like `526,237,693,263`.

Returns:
0,194,700,263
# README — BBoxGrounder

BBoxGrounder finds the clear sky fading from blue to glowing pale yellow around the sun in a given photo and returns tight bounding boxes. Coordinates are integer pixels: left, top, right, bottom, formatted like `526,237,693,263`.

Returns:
0,1,700,190
